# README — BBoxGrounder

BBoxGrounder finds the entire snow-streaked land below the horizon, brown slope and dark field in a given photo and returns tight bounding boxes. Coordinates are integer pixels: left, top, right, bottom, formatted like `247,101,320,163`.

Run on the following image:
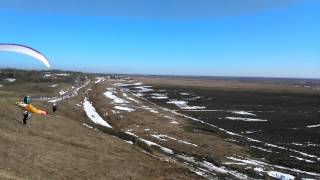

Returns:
0,71,320,179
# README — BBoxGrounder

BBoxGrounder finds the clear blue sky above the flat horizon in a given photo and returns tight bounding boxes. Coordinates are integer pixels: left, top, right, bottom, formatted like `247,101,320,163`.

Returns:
0,0,320,78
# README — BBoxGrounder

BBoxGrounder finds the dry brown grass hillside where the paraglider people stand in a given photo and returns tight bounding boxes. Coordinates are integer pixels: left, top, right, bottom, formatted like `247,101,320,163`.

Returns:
0,73,199,179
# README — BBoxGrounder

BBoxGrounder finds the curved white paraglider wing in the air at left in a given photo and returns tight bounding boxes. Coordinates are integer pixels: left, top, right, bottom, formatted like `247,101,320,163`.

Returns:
0,43,50,68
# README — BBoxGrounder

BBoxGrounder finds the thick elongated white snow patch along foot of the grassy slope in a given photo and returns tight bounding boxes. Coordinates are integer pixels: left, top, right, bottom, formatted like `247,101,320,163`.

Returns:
83,98,112,128
